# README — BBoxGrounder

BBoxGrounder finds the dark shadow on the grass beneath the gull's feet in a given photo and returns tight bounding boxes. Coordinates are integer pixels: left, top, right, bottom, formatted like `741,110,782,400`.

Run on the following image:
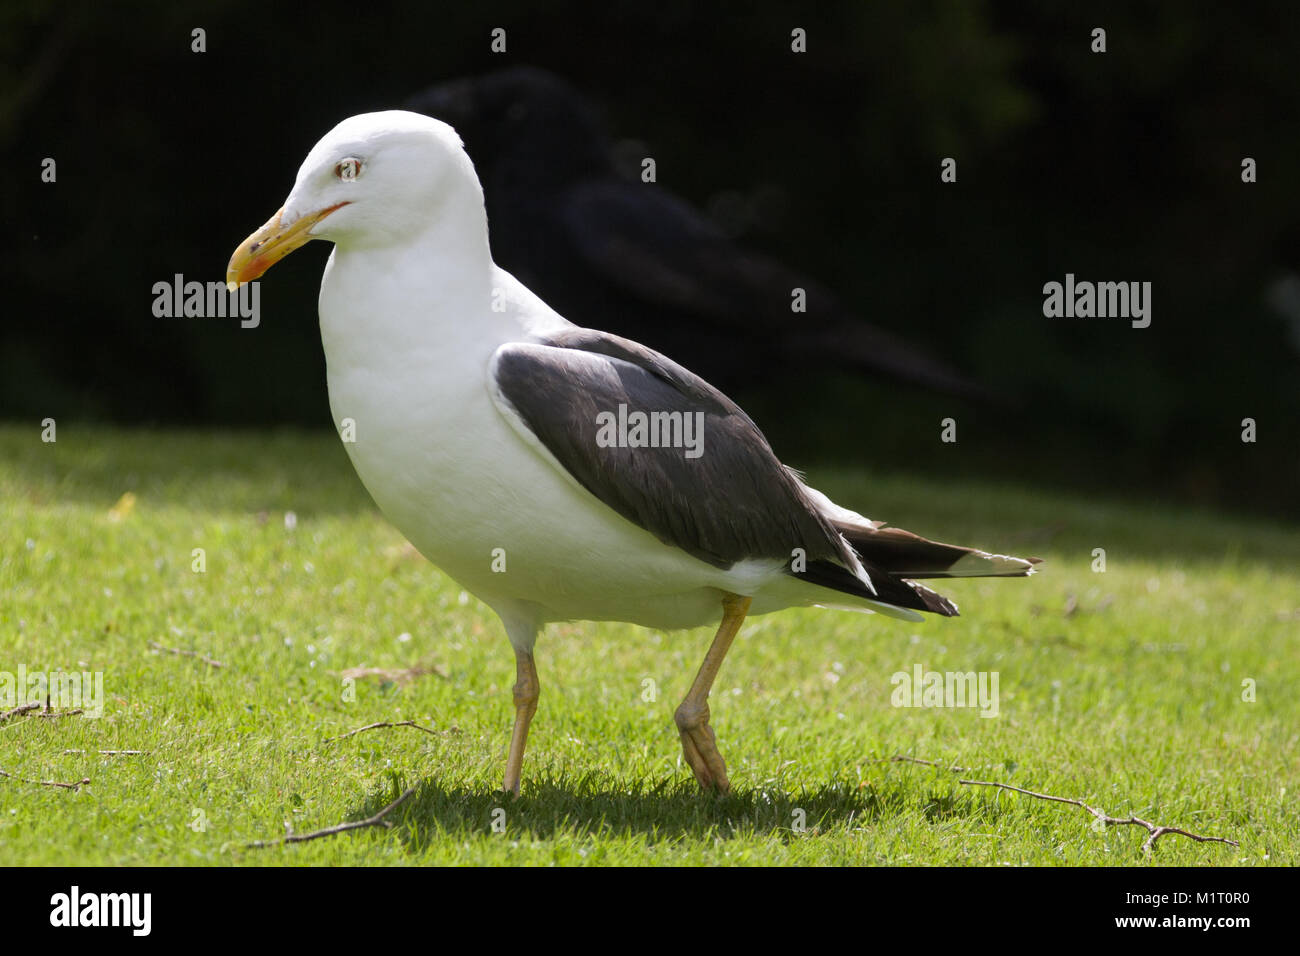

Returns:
343,774,1000,853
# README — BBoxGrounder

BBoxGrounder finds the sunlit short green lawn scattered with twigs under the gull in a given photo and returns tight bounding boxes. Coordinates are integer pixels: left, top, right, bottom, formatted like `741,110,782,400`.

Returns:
0,424,1300,866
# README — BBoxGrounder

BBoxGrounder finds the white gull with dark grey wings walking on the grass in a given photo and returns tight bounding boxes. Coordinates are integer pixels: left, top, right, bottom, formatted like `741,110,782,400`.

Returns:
226,111,1037,796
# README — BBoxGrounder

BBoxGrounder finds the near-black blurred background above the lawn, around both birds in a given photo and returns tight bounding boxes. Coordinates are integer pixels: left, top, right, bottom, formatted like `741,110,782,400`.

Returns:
0,0,1300,516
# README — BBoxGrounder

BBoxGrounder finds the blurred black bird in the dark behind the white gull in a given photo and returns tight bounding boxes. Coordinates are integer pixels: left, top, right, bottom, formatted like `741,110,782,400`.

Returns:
404,68,988,398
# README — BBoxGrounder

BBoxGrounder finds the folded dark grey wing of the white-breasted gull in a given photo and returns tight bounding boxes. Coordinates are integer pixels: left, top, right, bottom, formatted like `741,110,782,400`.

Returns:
491,328,861,567
